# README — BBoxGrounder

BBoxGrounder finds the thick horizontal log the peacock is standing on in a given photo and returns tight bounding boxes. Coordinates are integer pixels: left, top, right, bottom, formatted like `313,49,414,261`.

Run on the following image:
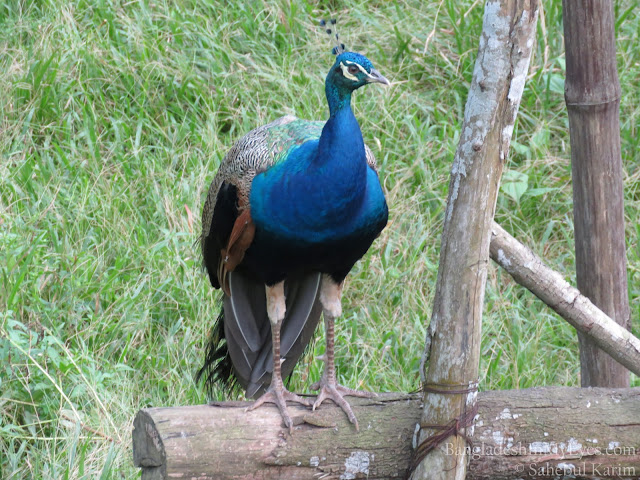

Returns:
133,387,640,480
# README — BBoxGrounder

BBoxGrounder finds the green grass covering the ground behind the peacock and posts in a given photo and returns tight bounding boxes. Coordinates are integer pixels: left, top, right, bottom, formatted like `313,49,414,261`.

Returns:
0,0,640,480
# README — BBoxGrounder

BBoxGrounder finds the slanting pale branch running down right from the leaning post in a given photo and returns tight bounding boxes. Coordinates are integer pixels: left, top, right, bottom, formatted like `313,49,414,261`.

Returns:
491,222,640,375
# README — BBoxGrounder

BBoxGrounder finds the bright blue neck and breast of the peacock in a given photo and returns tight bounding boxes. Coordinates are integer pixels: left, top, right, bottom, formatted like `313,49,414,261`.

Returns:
250,78,368,241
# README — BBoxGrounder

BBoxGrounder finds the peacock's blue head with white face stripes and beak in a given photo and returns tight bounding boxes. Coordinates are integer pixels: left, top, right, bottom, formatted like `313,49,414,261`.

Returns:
327,52,389,92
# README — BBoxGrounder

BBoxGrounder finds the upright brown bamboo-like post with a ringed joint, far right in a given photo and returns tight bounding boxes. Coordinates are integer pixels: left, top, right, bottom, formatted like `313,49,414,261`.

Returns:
562,0,630,387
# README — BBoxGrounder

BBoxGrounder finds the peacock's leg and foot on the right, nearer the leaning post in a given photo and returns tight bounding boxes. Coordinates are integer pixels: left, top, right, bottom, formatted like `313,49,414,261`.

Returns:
311,275,376,430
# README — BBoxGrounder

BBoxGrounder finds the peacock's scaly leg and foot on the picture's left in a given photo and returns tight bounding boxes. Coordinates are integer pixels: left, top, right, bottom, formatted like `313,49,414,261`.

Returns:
247,282,311,433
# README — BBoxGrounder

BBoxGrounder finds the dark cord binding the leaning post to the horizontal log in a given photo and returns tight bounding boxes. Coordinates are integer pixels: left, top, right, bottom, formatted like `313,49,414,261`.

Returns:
405,381,478,480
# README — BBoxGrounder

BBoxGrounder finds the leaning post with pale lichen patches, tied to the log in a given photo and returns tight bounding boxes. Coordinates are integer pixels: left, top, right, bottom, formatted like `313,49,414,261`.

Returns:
411,0,538,480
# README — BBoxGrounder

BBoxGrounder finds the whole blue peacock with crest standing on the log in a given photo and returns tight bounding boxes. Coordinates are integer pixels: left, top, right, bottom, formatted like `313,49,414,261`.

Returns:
197,24,389,431
